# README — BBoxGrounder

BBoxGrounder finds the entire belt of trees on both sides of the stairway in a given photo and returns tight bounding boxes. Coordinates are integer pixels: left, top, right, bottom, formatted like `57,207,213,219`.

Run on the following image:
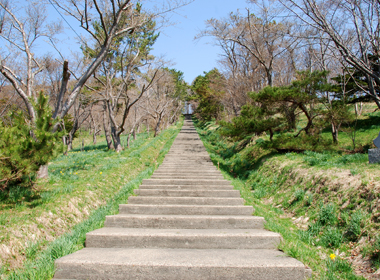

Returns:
0,0,380,189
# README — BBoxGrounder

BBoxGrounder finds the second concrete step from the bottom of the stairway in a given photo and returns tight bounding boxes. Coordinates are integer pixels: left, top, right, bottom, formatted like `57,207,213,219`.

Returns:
86,227,281,249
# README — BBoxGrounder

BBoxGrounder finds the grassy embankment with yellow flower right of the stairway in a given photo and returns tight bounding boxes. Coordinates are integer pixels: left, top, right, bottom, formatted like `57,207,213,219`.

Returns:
196,106,380,279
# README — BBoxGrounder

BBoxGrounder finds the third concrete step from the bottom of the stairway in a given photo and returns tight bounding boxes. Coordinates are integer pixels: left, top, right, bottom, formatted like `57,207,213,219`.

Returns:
104,214,264,229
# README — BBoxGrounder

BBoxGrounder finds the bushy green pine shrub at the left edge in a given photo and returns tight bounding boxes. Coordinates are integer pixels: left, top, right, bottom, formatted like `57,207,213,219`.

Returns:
0,93,62,191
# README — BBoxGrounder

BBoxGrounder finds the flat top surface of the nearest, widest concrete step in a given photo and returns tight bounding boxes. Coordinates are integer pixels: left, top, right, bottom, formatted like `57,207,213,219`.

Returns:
56,248,304,268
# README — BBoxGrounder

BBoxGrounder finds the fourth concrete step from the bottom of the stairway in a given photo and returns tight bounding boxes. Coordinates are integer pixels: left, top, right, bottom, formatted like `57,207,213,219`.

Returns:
119,204,254,216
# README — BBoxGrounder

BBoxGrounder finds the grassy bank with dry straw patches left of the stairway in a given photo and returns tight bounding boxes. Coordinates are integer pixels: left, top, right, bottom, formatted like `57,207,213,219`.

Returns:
0,119,183,280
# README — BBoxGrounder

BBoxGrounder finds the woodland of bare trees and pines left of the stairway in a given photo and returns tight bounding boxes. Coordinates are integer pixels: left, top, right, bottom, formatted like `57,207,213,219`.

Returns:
0,0,188,190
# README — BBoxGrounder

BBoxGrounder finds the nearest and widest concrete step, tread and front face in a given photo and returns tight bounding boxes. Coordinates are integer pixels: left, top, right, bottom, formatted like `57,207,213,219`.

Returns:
54,248,306,280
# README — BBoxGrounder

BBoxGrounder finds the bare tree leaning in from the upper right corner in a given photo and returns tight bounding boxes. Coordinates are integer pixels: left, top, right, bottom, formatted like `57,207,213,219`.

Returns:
280,0,380,108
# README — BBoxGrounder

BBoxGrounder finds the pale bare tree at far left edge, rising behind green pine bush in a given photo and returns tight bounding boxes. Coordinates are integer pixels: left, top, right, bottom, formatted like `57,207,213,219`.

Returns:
0,1,61,122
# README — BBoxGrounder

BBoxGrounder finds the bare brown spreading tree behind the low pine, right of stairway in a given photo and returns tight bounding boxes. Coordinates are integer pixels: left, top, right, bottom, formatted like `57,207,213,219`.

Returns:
197,0,297,86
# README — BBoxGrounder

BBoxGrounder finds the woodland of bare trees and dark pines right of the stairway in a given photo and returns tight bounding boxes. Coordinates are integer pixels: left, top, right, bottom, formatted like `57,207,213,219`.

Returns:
193,0,380,152
